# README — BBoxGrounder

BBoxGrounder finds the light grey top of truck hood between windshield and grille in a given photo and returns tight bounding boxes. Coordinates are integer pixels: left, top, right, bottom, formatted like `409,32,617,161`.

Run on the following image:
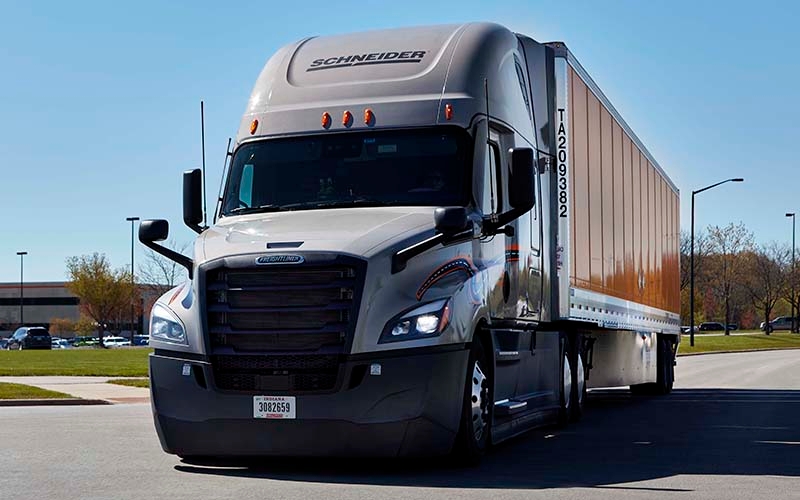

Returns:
196,207,434,263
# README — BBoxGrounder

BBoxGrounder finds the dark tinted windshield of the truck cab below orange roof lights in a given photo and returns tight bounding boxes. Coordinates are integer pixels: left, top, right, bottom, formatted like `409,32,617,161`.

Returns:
221,128,471,215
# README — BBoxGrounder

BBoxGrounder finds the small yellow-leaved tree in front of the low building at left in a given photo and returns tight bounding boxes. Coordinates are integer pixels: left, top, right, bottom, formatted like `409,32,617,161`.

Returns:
67,253,134,346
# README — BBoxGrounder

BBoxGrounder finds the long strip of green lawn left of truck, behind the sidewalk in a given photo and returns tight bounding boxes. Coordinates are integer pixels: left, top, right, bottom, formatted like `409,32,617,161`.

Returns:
0,348,153,377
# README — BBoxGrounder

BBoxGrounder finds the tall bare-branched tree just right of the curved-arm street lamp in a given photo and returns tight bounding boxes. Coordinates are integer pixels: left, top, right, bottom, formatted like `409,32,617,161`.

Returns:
708,222,753,335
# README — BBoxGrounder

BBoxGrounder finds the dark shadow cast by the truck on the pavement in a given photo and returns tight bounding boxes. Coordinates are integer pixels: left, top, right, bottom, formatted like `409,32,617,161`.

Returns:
175,389,800,491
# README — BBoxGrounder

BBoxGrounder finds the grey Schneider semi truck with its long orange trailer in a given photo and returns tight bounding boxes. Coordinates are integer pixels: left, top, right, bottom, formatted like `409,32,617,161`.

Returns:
139,23,680,462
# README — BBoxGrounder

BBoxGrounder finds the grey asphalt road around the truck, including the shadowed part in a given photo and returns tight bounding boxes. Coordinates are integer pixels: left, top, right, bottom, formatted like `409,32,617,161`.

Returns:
0,351,800,500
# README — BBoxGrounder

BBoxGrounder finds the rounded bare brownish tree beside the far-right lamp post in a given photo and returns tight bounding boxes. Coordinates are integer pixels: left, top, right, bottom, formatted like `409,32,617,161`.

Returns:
742,242,791,335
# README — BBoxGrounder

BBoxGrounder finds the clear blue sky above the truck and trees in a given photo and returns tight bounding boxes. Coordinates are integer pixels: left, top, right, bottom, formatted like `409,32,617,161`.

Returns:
0,0,800,281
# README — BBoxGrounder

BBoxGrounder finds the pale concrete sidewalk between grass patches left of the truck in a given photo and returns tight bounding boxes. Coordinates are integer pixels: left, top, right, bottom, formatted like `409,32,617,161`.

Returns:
0,377,150,404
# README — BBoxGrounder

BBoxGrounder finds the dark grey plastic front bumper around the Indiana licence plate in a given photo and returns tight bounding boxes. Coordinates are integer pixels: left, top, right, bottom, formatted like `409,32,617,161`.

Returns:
150,346,469,457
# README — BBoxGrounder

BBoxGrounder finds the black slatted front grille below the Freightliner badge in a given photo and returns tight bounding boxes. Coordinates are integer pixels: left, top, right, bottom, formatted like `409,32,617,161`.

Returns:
205,258,363,393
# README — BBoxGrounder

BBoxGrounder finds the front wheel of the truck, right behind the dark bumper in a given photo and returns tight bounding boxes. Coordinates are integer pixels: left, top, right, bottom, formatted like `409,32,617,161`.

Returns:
453,338,494,465
